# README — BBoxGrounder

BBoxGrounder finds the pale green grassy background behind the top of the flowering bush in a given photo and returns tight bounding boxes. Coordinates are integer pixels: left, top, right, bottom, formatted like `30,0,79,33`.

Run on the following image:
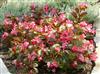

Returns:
0,0,100,23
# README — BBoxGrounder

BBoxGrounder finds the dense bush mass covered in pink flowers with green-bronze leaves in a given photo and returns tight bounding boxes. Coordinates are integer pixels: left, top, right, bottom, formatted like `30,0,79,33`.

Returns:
2,5,97,71
